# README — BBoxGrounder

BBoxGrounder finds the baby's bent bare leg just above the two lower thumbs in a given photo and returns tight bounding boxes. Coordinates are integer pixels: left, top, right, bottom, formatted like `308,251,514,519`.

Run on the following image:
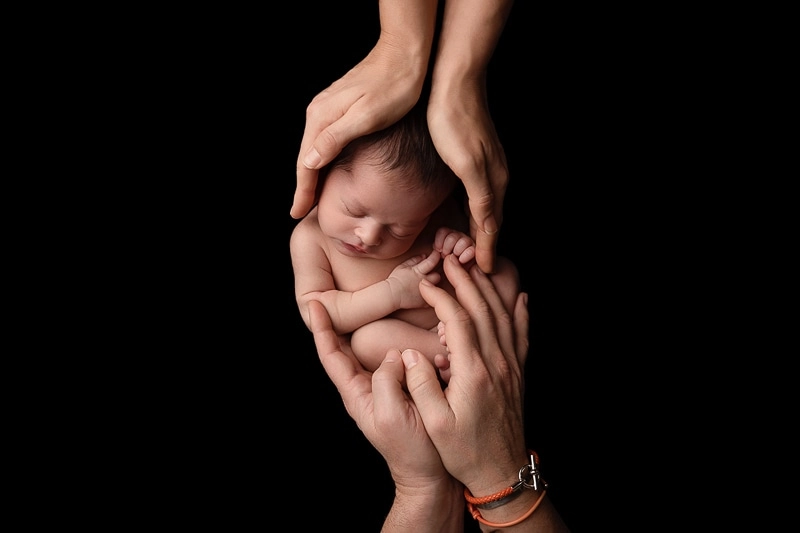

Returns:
350,318,447,372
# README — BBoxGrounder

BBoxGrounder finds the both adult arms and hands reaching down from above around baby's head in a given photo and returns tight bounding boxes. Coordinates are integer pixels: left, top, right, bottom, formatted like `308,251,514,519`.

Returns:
290,0,513,272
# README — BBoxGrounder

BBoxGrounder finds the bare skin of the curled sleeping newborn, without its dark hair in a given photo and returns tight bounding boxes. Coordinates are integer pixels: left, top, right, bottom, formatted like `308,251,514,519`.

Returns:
290,145,519,380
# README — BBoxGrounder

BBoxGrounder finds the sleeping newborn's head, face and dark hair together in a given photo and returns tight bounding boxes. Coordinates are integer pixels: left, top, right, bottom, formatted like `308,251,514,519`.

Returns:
317,105,458,259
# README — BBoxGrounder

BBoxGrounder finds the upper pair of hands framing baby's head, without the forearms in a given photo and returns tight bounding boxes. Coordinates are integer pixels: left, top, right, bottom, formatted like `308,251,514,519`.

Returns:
290,40,508,272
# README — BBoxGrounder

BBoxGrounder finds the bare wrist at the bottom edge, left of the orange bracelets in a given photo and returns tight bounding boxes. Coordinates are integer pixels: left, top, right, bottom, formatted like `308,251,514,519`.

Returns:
381,478,464,533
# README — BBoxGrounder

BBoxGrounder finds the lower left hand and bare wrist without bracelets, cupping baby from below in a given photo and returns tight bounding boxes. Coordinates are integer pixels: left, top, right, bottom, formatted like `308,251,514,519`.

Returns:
308,301,464,533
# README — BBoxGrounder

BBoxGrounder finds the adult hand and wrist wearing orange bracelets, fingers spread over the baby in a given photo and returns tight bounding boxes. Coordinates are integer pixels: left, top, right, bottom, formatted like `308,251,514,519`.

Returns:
402,255,568,532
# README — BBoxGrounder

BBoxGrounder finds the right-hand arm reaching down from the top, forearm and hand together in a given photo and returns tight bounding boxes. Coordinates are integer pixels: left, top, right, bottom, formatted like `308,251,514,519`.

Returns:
428,0,514,273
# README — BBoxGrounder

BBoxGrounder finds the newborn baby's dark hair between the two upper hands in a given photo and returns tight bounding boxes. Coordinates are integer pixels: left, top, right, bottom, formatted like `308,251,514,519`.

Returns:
329,97,458,190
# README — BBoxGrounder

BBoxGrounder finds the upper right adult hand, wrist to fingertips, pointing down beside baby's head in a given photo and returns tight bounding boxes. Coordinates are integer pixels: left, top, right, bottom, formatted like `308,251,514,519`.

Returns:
428,84,508,273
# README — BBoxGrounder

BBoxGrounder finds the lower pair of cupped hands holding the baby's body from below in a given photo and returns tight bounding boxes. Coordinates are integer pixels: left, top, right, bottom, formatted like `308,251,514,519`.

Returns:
309,255,528,508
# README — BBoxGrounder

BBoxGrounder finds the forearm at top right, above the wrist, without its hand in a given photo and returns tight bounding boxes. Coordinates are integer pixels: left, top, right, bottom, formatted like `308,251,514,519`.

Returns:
433,0,513,82
